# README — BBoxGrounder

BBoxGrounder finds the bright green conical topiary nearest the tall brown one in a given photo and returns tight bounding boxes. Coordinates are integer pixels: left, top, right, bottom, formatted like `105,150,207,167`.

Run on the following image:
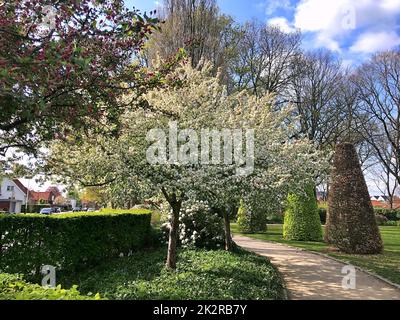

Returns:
283,186,322,241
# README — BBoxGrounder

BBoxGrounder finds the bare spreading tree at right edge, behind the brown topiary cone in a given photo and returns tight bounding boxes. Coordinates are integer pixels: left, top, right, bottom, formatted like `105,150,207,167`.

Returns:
353,51,400,184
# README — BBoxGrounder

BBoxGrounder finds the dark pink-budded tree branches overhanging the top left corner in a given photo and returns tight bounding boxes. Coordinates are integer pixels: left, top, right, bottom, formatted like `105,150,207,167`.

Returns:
0,0,158,156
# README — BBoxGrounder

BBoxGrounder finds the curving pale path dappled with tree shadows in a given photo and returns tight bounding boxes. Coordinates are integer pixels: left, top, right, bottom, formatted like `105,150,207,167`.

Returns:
233,235,400,300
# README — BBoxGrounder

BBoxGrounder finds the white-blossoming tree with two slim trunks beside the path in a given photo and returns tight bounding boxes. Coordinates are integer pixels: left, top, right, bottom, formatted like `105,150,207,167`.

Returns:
47,64,326,268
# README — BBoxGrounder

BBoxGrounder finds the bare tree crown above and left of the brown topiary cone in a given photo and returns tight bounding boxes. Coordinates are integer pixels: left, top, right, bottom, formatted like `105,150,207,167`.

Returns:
286,50,352,146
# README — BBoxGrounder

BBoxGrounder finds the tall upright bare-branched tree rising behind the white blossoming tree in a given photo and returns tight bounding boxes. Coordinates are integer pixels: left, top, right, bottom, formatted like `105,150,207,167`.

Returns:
146,0,233,74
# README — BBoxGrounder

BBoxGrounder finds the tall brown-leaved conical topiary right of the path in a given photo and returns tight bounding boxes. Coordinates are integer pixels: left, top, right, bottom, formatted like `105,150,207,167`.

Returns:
325,143,383,254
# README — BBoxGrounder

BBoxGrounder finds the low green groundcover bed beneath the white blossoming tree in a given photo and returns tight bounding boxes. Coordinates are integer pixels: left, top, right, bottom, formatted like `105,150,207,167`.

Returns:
57,248,284,300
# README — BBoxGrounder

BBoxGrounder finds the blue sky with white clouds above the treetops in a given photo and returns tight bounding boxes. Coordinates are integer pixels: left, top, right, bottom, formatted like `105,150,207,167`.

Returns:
126,0,400,65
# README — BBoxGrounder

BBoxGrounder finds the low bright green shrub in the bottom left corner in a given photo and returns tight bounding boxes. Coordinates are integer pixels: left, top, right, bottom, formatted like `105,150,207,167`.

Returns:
0,273,101,300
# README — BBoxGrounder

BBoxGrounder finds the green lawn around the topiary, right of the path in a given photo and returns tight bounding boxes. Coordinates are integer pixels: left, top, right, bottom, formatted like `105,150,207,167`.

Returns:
232,223,400,284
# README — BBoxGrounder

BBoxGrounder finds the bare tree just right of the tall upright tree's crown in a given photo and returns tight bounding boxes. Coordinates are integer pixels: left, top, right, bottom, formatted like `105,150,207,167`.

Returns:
229,22,301,95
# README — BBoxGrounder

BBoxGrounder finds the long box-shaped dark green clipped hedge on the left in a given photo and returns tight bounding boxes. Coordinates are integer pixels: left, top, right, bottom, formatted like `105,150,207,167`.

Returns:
0,210,151,277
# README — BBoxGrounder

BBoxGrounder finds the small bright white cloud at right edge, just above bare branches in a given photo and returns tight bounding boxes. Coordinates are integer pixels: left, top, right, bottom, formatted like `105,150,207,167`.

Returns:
350,32,400,53
